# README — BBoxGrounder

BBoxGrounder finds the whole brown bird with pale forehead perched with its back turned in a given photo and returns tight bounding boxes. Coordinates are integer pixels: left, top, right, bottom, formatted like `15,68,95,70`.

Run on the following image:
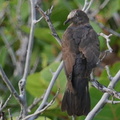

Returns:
61,9,100,116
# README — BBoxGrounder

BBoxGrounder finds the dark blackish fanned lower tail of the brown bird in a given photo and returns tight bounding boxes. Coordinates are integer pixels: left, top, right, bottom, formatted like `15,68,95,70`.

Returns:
61,78,90,116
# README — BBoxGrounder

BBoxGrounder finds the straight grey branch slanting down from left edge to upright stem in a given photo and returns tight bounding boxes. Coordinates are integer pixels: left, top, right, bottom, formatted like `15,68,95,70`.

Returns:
0,66,22,104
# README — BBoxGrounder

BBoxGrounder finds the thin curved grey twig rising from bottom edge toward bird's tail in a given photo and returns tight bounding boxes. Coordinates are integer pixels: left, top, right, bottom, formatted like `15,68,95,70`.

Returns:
22,90,59,120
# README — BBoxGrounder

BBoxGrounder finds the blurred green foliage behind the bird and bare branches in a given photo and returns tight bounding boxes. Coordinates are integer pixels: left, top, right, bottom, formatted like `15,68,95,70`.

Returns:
0,0,120,120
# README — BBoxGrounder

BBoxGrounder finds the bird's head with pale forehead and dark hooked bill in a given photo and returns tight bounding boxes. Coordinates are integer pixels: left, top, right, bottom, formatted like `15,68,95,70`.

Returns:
64,9,89,24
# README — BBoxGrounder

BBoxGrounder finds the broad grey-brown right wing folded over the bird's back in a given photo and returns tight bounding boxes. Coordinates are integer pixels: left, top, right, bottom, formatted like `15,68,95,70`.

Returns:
73,25,100,68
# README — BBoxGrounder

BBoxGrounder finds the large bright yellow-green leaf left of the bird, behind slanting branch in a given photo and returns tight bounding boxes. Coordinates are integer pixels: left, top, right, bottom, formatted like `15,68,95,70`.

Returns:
27,62,59,97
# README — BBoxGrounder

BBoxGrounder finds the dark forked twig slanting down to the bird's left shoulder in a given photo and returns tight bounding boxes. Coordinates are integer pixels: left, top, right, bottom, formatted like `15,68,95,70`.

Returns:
36,5,61,45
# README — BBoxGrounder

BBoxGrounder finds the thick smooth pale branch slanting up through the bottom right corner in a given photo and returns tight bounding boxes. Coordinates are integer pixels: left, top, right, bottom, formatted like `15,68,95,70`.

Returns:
85,70,120,120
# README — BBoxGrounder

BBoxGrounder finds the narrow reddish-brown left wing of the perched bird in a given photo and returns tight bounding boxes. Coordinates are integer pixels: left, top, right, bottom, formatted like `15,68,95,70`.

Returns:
62,29,76,80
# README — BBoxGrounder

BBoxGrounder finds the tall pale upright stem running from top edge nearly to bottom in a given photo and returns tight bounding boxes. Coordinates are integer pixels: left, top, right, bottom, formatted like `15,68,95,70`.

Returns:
19,0,36,119
